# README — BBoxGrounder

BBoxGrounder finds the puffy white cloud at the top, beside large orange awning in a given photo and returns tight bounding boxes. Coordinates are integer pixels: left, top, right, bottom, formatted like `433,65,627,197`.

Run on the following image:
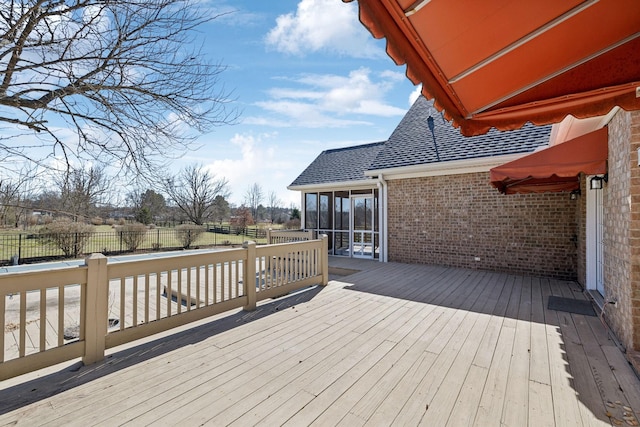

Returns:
265,0,386,58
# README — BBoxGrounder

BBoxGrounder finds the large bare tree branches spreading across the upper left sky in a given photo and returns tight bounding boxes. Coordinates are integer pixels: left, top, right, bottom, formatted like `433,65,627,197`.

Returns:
0,0,238,176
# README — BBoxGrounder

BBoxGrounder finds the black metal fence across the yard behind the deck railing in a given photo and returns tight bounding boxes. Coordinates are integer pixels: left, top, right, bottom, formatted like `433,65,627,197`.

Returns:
0,226,266,265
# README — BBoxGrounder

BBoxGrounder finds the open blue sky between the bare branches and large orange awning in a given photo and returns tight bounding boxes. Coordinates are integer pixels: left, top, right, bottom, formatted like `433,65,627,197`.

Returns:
180,0,417,207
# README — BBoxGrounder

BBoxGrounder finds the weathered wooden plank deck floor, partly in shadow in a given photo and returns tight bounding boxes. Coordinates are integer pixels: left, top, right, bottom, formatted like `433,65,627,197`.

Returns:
0,258,640,427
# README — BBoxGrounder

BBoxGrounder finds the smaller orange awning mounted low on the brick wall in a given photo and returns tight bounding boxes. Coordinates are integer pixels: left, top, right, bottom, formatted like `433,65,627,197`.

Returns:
490,127,608,194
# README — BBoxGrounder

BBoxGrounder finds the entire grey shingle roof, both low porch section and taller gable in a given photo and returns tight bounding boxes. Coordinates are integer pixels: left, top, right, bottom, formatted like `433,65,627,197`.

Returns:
291,96,551,186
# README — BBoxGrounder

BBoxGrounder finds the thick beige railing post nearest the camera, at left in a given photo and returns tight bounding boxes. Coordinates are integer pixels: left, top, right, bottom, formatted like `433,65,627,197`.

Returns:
82,254,109,365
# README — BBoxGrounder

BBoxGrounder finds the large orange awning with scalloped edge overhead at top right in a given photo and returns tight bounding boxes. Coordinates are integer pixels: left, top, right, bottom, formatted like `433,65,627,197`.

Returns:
343,0,640,136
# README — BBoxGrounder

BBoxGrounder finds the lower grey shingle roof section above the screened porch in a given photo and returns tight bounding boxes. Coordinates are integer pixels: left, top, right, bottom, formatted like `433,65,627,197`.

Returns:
291,142,384,186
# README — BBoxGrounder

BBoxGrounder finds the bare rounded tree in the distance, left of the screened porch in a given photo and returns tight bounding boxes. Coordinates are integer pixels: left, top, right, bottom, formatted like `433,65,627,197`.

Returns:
165,165,231,225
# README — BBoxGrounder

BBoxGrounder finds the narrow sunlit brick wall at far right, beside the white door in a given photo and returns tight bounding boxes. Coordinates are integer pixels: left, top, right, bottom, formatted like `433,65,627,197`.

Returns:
604,111,640,348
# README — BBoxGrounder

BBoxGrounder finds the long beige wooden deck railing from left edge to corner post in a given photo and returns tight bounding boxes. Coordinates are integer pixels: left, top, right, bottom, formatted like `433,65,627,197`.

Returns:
0,236,329,380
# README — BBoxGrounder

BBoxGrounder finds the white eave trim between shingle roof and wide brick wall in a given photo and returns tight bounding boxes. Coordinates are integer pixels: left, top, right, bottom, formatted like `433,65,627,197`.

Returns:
362,152,533,181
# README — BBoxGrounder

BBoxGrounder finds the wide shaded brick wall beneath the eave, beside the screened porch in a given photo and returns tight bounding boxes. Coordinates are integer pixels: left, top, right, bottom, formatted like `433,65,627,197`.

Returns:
388,172,580,280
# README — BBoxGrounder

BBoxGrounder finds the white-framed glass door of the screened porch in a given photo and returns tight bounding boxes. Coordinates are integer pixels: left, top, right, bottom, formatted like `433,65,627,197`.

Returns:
350,195,375,258
